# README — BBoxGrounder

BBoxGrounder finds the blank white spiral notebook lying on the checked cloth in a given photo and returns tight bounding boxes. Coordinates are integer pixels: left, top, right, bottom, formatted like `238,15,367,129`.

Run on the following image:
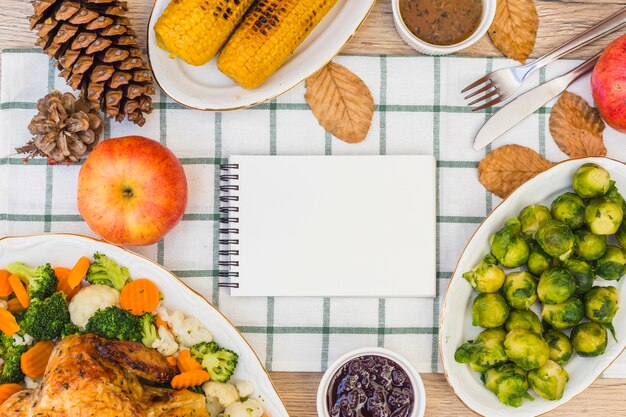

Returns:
220,156,436,297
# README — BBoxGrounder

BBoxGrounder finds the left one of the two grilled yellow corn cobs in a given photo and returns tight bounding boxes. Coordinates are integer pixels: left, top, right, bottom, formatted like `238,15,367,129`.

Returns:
154,0,254,65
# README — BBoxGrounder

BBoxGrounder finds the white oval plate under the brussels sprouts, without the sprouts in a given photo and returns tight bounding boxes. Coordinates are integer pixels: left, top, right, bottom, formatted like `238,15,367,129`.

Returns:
439,158,626,417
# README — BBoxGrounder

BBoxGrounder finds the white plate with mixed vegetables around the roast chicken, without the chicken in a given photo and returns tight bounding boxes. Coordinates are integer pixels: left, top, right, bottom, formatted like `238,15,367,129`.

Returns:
0,234,288,417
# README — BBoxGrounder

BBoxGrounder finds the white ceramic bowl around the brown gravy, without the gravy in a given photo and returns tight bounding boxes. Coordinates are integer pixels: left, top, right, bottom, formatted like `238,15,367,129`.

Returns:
391,0,497,55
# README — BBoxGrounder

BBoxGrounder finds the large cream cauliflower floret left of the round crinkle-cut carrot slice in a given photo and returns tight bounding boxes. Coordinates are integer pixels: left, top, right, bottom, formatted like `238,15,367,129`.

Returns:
68,285,120,331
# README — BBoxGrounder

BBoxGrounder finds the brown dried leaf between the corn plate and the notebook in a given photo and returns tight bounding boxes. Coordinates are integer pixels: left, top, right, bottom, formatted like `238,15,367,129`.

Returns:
304,62,374,143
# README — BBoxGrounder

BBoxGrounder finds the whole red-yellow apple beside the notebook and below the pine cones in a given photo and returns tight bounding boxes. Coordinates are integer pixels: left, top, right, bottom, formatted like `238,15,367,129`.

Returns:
78,136,187,245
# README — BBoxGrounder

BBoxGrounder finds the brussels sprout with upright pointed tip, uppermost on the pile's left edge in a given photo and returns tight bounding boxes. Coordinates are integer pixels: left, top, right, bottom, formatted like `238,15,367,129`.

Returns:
489,218,530,268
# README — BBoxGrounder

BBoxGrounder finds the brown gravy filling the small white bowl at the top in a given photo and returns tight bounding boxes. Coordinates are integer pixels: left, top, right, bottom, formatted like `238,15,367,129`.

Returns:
400,0,483,45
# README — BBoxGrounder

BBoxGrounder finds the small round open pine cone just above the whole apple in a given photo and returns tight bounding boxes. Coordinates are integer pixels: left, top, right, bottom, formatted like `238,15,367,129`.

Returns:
16,91,102,164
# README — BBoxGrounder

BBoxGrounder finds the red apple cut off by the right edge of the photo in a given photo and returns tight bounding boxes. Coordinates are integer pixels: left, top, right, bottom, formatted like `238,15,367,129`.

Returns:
591,35,626,133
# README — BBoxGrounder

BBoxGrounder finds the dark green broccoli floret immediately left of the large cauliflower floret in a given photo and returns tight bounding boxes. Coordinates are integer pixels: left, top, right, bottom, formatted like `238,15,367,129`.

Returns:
19,291,70,340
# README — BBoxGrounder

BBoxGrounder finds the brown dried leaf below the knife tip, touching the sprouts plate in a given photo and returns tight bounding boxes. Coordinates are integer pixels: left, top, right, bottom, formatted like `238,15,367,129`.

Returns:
478,145,552,198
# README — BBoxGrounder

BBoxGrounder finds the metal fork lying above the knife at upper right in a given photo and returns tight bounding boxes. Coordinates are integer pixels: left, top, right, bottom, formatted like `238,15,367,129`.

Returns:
461,9,626,111
